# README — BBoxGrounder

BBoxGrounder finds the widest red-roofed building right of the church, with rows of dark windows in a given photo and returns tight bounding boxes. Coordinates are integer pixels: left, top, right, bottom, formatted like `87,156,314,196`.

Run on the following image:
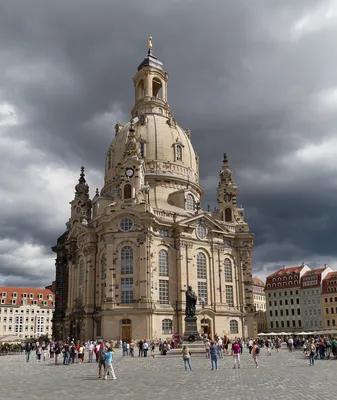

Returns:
265,264,310,333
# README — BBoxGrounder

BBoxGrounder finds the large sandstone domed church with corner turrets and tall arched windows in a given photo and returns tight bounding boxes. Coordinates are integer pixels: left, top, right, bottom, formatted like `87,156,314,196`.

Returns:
52,38,255,341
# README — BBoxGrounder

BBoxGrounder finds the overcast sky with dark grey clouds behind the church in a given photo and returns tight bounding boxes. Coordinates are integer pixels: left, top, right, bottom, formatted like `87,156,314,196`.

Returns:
0,0,337,286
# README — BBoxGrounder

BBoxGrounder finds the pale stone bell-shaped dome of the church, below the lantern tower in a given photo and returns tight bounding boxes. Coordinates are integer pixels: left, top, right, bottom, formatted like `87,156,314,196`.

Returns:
105,113,199,185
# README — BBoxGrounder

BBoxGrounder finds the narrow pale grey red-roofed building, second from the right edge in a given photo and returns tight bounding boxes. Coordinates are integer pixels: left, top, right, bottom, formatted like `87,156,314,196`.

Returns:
300,266,332,332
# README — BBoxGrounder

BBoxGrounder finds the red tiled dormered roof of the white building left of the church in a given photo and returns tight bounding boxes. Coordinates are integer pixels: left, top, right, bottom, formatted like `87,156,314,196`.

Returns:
0,286,55,307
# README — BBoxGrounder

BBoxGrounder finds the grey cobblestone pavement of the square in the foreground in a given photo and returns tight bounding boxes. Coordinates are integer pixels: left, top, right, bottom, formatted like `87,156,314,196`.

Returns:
0,349,337,400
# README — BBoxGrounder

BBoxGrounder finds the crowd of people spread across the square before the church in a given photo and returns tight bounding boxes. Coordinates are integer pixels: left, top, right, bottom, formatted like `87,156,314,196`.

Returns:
19,334,337,379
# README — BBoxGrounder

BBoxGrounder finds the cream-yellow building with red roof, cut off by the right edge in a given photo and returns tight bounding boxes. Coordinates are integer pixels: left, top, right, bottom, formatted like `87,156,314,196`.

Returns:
322,271,337,329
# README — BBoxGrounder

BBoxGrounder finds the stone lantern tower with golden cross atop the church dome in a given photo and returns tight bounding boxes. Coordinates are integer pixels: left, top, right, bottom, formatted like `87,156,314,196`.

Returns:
131,36,171,118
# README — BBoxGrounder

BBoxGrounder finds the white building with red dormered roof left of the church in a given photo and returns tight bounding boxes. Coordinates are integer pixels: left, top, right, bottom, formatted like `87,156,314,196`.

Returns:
0,286,55,339
